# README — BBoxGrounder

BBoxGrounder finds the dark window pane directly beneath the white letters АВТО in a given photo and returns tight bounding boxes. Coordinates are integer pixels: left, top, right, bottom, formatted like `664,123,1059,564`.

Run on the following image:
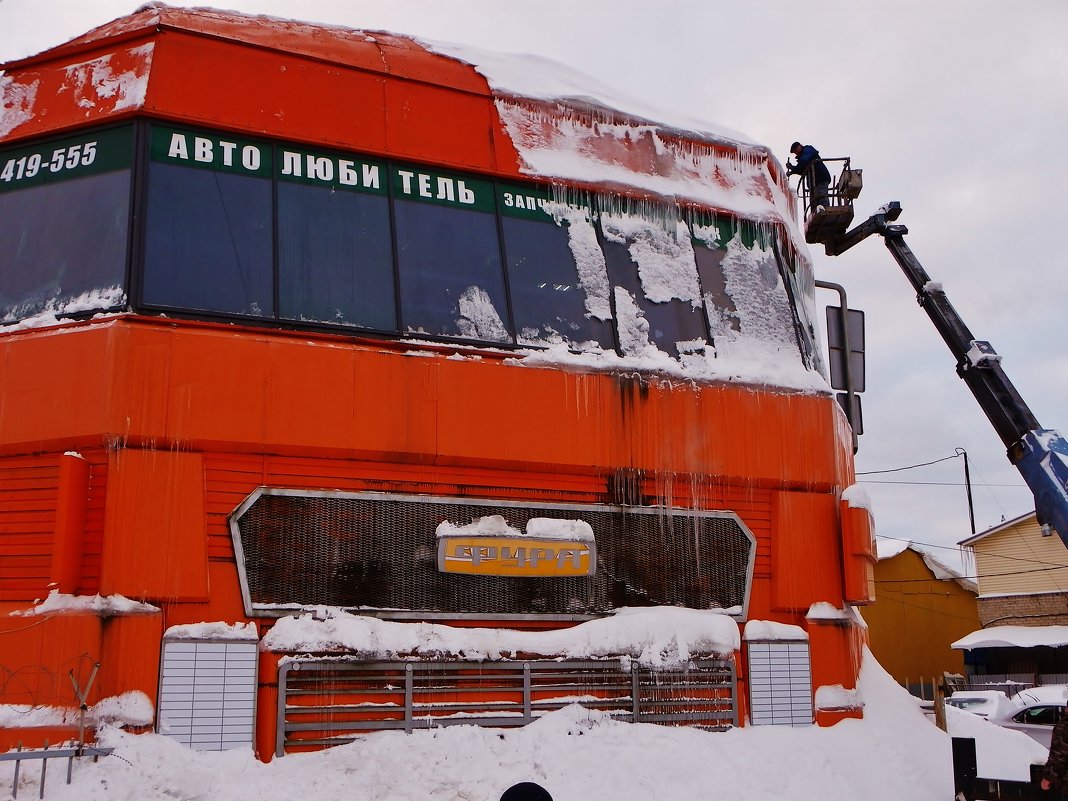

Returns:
143,162,274,317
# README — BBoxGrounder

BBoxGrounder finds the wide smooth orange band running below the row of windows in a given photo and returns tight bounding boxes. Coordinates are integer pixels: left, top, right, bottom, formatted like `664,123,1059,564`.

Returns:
0,317,843,495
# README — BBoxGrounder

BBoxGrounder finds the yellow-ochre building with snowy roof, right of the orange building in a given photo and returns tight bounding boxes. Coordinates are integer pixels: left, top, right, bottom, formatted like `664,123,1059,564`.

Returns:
863,540,979,691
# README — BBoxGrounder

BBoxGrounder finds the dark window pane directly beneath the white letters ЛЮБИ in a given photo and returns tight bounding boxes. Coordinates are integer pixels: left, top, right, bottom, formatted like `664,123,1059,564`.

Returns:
278,183,396,331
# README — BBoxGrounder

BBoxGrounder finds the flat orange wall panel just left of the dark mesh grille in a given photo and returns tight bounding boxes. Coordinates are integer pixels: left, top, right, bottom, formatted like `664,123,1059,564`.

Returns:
100,449,208,601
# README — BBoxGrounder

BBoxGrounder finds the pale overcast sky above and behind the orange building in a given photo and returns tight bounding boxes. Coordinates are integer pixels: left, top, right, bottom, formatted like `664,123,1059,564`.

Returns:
0,0,1068,576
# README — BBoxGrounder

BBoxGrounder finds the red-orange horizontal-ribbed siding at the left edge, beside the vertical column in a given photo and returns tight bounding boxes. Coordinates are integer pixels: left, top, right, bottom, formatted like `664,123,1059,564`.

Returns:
0,454,60,601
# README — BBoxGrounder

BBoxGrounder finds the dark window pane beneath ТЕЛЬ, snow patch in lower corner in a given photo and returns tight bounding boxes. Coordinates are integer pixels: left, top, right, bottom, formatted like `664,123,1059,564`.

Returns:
394,200,512,342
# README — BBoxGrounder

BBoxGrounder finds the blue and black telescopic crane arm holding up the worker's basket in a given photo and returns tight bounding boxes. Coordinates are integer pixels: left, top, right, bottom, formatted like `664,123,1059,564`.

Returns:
824,202,1068,546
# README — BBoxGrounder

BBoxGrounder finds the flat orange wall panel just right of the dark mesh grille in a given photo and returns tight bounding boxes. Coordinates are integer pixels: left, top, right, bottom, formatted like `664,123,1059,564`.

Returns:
772,492,843,612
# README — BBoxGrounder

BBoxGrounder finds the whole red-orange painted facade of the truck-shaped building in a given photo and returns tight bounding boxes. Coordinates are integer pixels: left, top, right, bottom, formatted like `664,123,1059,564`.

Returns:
0,9,871,758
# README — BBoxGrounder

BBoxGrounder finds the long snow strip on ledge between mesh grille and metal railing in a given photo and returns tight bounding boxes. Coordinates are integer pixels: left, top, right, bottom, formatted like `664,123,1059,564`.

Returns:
264,607,739,668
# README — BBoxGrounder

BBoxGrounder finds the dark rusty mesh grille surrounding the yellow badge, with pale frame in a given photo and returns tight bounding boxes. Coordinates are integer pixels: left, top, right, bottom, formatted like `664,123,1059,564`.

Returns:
232,490,754,615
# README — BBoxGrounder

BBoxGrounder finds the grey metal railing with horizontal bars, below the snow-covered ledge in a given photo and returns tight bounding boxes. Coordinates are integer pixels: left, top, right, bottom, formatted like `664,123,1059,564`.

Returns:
276,658,738,756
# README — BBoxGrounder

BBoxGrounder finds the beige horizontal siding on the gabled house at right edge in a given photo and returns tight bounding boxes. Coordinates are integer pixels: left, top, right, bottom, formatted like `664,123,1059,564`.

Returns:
973,518,1068,596
